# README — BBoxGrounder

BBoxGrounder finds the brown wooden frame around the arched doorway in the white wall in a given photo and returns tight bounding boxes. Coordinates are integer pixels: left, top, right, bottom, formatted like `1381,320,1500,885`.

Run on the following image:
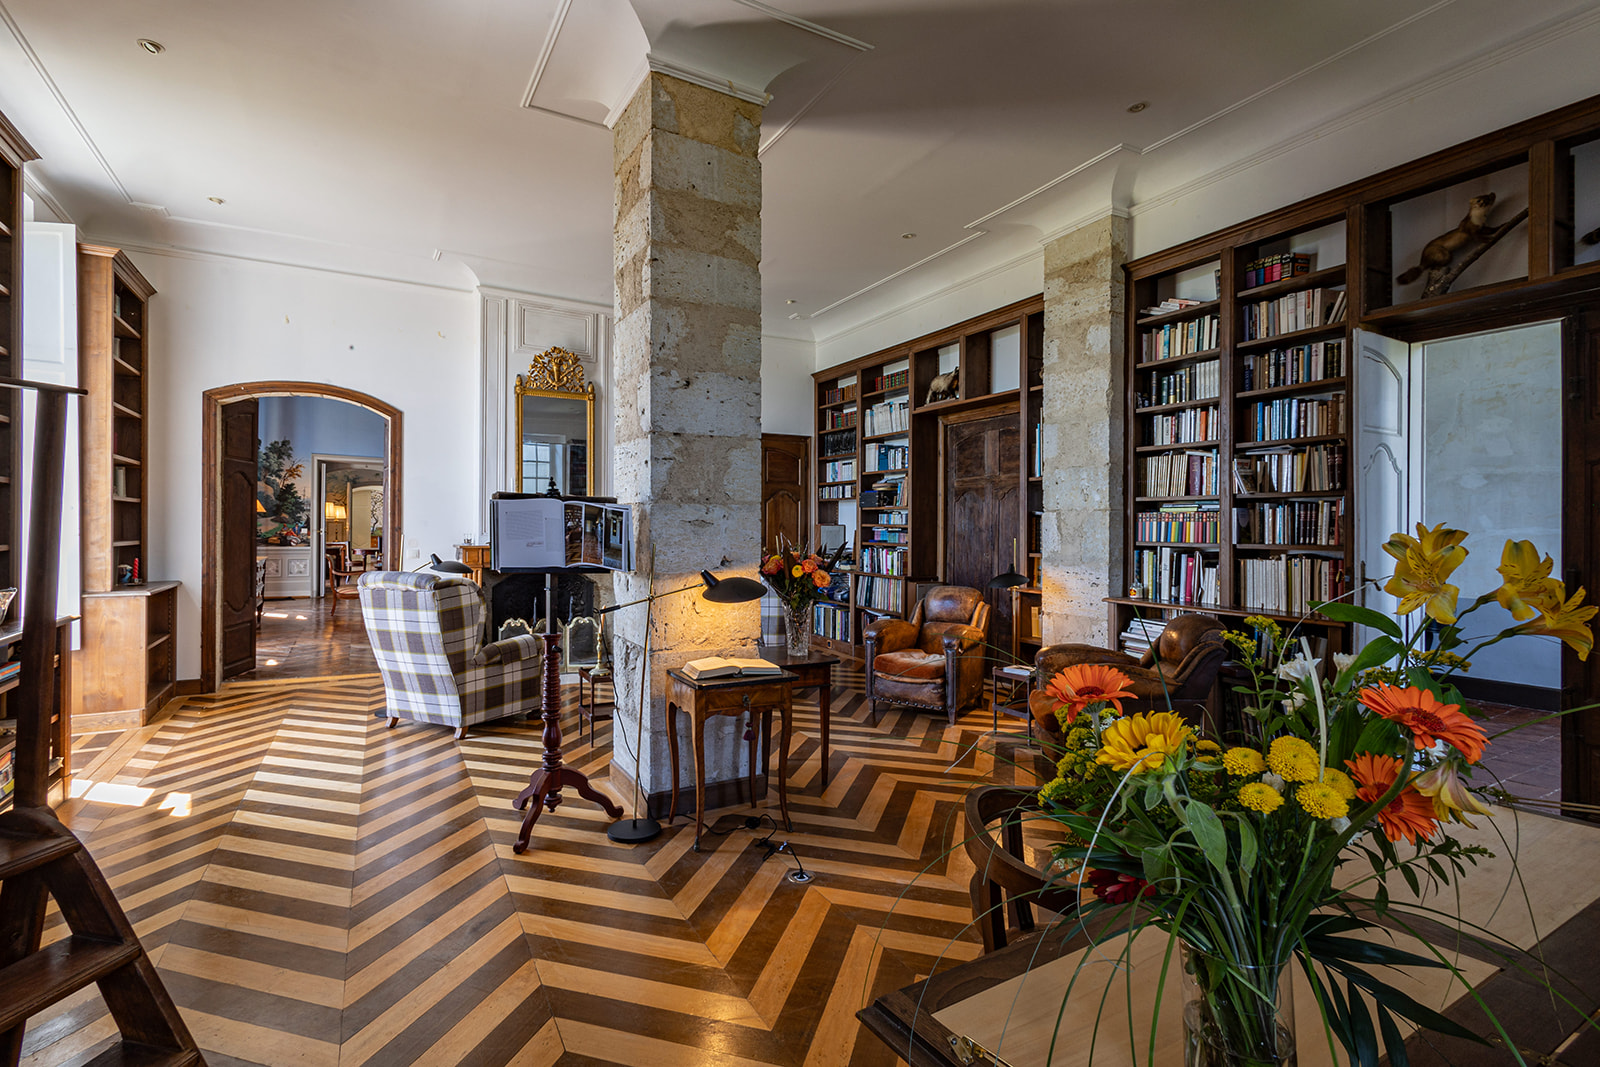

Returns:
198,381,405,693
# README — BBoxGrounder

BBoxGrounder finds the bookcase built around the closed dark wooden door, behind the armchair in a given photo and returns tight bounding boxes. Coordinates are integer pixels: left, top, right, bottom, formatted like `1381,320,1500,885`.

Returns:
813,298,1045,656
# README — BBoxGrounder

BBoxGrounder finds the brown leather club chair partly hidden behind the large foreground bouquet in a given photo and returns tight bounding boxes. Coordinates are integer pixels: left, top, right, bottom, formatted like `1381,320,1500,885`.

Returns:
1029,614,1227,733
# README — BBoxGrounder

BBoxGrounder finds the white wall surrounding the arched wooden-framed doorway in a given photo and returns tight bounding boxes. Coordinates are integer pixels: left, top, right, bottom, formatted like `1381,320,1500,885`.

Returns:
130,250,478,678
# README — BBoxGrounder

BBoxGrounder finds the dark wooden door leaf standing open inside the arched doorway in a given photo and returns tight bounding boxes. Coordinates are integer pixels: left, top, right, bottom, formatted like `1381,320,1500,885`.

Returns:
219,400,256,680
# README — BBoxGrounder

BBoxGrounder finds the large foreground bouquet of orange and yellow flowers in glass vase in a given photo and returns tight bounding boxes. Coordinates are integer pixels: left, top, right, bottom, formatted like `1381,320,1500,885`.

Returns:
1034,525,1595,1067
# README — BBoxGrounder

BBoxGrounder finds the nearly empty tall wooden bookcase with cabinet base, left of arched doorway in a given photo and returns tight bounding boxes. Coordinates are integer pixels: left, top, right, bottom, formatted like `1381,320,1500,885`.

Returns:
78,245,178,726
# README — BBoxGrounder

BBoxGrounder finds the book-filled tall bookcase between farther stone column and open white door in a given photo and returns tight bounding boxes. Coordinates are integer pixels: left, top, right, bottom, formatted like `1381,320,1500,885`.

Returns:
1112,213,1354,651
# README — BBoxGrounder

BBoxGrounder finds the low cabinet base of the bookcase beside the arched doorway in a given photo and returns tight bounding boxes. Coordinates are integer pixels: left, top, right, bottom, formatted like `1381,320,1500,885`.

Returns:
74,581,179,731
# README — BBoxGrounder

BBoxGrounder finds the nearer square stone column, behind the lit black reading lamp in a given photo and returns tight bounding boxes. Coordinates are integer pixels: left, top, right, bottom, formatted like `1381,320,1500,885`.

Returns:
611,72,764,814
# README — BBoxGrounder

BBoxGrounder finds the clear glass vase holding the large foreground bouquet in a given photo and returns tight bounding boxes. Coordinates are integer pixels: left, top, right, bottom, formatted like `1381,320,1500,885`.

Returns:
1182,942,1294,1067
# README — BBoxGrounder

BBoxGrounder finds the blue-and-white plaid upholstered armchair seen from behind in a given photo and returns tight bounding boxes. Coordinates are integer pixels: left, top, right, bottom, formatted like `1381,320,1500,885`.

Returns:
357,571,544,739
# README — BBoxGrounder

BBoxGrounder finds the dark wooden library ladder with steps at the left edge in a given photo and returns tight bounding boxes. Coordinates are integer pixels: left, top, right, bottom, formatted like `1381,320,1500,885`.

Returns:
0,378,205,1067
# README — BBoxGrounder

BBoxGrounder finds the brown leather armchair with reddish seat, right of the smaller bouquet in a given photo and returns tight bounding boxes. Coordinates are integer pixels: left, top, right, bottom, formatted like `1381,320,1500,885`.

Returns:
864,585,989,726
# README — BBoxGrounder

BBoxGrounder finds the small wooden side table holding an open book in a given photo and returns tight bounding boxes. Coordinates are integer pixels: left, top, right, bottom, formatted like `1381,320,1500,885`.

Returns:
667,669,798,853
